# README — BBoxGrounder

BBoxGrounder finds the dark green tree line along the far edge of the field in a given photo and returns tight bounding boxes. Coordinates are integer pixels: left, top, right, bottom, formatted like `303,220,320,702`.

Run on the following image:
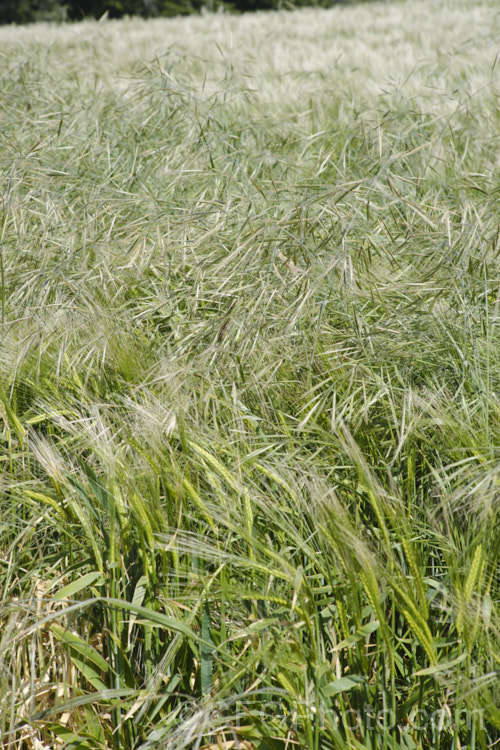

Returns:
0,0,345,24
